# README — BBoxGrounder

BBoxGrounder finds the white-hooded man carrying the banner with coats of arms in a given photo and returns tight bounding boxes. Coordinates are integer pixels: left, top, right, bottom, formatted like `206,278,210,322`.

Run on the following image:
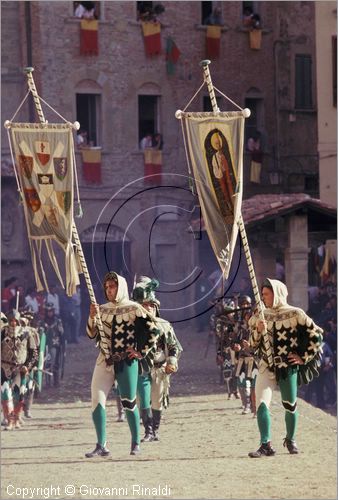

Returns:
86,272,159,458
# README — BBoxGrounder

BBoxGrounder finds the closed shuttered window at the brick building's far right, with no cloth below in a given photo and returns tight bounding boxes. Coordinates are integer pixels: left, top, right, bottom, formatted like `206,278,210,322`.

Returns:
295,54,313,109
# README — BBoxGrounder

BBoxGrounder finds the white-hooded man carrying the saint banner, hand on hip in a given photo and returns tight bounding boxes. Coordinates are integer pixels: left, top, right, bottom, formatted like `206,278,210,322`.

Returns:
249,279,323,458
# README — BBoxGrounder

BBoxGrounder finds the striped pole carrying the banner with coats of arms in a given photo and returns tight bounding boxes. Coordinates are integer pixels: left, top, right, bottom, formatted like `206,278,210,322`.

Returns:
24,67,110,359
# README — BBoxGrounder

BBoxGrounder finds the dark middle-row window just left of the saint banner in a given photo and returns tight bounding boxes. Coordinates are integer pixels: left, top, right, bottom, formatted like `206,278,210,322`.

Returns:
138,95,160,145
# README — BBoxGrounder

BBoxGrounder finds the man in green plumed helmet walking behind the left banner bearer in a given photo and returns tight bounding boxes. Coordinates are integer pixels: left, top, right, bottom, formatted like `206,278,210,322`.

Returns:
133,276,183,441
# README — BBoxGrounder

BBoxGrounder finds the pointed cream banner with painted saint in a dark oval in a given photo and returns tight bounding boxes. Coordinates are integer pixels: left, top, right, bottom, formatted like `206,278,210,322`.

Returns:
181,112,244,279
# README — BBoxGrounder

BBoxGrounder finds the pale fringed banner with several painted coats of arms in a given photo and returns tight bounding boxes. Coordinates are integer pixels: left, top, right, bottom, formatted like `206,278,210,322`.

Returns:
11,123,79,296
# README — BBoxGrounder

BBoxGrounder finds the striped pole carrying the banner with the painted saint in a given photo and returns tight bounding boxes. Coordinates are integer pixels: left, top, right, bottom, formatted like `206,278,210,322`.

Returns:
200,59,274,368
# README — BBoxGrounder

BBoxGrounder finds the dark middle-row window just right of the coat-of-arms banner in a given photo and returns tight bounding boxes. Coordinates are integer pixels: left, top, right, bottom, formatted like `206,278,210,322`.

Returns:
76,94,101,146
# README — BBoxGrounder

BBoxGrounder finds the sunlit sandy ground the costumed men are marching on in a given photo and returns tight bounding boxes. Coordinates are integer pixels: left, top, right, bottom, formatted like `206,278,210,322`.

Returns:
1,329,337,500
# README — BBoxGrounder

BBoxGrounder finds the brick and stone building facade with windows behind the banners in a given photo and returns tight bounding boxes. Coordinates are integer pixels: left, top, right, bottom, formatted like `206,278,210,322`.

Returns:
1,1,319,319
